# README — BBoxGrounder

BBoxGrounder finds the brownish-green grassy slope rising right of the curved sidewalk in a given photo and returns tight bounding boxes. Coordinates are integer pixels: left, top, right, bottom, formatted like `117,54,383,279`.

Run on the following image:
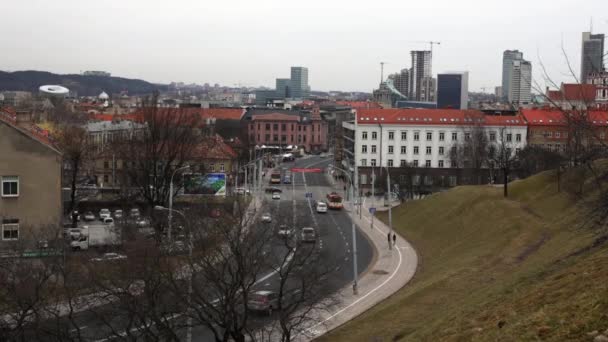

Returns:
321,165,608,341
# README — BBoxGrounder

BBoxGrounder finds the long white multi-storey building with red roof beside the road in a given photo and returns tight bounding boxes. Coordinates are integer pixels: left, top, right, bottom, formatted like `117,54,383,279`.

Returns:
343,109,527,184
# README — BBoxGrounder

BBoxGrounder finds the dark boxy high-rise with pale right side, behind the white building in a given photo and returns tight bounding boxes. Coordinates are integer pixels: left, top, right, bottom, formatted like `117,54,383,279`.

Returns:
437,71,469,109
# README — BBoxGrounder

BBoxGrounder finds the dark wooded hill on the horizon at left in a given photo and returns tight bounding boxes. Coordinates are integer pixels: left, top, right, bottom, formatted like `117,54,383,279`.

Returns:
0,70,167,96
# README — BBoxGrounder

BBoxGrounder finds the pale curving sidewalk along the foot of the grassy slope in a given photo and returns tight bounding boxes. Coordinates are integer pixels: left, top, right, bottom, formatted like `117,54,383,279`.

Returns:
302,176,418,340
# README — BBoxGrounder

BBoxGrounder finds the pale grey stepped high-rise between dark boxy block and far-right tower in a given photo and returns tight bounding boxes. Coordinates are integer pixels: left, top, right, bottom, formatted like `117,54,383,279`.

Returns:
502,50,532,105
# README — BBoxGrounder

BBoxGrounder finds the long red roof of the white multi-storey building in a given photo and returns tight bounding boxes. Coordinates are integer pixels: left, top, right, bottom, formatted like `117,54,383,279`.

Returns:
357,109,526,126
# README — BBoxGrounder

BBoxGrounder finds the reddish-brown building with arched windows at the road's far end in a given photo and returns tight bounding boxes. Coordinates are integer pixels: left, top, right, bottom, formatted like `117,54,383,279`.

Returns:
245,107,328,152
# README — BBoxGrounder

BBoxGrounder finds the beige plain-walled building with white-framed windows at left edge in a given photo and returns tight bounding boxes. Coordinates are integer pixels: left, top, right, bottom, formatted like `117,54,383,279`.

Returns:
0,110,62,244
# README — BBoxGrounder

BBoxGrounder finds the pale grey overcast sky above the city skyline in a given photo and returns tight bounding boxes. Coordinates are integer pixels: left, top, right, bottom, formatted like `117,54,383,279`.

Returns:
0,0,608,92
